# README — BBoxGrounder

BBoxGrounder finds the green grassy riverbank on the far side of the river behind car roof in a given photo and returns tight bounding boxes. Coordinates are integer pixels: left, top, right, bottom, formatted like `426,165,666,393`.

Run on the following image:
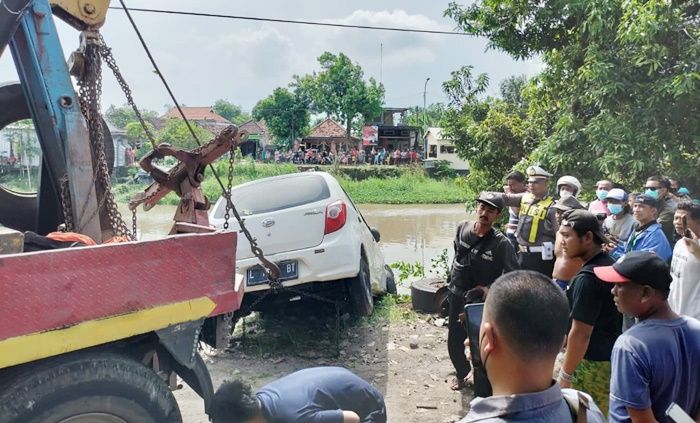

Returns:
114,161,467,204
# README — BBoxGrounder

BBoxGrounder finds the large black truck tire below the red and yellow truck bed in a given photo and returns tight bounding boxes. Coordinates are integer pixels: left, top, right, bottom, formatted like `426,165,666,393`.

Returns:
0,353,182,423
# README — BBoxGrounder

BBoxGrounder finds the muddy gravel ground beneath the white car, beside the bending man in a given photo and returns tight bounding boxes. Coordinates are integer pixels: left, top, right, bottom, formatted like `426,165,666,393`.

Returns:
176,297,472,423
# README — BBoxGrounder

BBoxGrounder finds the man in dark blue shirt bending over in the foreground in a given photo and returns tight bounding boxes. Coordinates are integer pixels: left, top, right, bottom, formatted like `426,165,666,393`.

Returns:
209,367,386,423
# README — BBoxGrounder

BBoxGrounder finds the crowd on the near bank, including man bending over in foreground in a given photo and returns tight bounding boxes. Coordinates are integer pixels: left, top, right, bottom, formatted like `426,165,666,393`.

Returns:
205,166,700,423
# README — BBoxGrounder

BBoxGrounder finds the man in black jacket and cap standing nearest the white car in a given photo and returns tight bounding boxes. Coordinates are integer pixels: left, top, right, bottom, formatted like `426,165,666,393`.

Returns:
447,192,518,390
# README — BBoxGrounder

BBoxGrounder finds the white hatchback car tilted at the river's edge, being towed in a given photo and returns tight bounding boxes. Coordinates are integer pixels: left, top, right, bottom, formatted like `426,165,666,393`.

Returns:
209,172,396,315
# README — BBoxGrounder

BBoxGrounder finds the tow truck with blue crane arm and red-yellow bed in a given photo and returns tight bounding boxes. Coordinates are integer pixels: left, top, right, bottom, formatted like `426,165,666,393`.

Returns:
0,0,254,423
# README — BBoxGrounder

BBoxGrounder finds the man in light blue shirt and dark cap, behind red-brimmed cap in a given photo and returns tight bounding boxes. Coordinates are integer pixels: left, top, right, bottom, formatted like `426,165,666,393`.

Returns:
610,194,672,262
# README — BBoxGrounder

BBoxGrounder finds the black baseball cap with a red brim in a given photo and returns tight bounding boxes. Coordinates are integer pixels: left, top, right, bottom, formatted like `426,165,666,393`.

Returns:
593,251,672,291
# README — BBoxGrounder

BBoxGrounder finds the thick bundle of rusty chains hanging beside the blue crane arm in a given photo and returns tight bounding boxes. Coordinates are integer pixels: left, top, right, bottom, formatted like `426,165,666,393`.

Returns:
76,32,130,236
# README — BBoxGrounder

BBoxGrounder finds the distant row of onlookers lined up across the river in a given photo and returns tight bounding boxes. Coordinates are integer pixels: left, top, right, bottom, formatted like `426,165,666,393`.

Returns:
258,147,421,166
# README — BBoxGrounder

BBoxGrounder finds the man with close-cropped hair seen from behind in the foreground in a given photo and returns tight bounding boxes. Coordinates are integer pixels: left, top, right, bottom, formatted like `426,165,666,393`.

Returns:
460,271,605,423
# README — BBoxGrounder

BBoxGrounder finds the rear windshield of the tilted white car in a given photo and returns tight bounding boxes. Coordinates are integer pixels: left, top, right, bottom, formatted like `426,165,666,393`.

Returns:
214,175,331,219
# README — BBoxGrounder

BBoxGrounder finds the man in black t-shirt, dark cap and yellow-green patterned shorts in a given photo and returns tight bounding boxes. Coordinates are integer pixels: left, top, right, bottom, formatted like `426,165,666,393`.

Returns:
559,210,622,413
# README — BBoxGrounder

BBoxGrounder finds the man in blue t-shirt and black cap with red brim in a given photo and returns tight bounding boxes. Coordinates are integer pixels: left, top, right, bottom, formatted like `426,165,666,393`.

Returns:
594,251,700,423
